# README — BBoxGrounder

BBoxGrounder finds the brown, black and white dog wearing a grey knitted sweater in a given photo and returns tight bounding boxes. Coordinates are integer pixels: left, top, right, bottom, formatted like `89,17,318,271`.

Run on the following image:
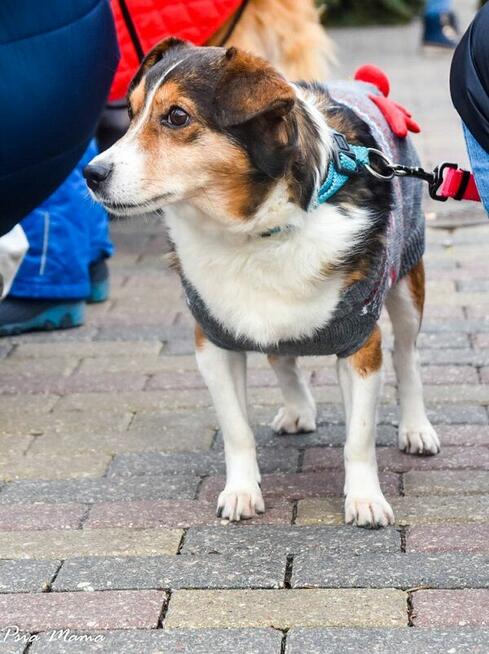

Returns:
85,38,440,527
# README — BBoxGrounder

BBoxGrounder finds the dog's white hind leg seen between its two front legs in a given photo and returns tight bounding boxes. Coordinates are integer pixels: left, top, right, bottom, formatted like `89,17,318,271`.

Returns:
268,355,316,434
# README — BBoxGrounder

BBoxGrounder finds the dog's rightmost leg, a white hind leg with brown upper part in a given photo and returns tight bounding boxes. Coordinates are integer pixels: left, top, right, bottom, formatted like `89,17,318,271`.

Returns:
386,260,440,454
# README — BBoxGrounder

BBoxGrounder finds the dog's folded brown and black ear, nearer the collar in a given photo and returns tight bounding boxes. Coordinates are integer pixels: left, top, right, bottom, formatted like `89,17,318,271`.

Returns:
214,48,297,178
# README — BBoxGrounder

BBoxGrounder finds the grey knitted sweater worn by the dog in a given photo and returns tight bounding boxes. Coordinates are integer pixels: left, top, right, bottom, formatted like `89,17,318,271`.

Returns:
182,82,425,357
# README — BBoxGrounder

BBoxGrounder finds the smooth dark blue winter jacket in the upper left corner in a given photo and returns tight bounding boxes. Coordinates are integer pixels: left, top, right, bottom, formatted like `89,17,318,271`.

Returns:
0,0,119,235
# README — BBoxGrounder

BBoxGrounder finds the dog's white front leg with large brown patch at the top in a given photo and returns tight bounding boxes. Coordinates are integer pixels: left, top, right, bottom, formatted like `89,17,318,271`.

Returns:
338,326,394,527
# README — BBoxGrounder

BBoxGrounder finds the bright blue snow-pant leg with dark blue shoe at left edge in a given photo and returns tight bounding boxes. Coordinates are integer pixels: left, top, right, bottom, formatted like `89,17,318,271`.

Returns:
0,138,111,336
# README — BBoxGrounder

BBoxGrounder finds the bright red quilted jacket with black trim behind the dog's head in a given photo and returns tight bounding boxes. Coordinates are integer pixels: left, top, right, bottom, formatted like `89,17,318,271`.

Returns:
109,0,241,100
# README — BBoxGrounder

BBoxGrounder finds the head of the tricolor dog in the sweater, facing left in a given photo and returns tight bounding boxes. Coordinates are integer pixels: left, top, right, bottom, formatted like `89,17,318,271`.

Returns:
85,38,297,221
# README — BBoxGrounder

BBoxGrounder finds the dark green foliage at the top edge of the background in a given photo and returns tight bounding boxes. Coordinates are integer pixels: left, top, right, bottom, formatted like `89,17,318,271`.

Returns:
317,0,424,25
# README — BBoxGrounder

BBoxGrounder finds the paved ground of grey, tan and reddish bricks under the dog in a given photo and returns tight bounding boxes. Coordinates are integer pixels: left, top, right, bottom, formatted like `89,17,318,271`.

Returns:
0,2,489,654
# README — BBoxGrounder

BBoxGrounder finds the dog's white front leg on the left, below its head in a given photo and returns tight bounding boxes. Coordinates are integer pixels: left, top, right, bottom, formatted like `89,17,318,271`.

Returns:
195,326,265,520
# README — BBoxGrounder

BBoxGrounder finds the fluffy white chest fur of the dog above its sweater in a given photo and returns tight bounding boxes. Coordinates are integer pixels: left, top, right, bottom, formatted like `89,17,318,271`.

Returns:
167,207,365,346
